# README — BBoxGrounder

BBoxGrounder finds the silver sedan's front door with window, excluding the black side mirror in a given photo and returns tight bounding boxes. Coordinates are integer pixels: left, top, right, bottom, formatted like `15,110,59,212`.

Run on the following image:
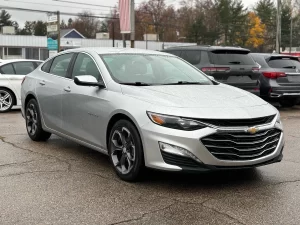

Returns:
62,53,109,148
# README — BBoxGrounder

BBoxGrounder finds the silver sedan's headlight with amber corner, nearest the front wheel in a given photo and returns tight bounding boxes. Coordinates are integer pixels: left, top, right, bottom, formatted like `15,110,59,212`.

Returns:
147,112,206,131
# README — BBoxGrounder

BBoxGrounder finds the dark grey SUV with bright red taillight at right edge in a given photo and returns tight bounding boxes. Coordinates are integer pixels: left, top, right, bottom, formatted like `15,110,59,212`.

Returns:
251,53,300,107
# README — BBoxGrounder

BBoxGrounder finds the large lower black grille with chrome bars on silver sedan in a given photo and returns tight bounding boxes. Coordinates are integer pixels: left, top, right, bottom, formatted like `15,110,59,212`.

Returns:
201,129,281,161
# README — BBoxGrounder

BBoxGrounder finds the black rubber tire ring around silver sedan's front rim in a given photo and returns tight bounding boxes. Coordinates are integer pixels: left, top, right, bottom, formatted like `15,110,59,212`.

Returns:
108,120,145,181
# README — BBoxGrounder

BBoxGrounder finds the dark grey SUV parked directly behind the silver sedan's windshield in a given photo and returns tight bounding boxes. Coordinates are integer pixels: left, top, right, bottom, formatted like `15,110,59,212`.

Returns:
163,46,261,95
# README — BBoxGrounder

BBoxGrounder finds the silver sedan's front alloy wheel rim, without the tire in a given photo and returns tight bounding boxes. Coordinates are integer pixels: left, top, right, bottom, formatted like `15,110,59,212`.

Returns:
111,127,136,174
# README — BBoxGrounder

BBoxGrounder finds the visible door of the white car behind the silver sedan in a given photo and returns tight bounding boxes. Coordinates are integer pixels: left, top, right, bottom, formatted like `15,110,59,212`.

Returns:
9,61,36,99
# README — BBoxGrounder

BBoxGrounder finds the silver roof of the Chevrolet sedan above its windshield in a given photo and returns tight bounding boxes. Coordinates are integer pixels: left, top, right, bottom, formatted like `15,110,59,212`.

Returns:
61,47,174,56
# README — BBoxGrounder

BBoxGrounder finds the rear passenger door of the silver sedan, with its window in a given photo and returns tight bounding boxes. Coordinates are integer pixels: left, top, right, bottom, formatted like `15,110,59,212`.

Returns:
36,53,74,132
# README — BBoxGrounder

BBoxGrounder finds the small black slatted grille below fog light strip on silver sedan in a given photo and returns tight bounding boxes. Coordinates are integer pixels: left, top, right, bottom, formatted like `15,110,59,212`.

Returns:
161,151,199,168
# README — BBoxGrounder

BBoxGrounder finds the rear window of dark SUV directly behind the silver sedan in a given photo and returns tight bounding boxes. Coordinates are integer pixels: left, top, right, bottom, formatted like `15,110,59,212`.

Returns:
209,50,255,65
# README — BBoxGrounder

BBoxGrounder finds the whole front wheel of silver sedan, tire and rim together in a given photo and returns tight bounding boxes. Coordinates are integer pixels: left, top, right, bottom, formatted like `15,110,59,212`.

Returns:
108,120,145,182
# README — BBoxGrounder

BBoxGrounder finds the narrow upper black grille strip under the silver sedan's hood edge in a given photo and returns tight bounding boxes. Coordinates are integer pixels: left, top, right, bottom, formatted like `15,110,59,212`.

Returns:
197,115,275,127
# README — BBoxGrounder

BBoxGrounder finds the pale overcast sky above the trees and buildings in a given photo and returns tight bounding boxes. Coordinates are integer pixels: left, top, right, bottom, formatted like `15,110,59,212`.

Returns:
0,0,255,27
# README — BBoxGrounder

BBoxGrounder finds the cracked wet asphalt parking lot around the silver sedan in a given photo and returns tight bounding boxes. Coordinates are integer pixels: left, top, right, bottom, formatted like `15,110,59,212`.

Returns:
0,107,300,225
